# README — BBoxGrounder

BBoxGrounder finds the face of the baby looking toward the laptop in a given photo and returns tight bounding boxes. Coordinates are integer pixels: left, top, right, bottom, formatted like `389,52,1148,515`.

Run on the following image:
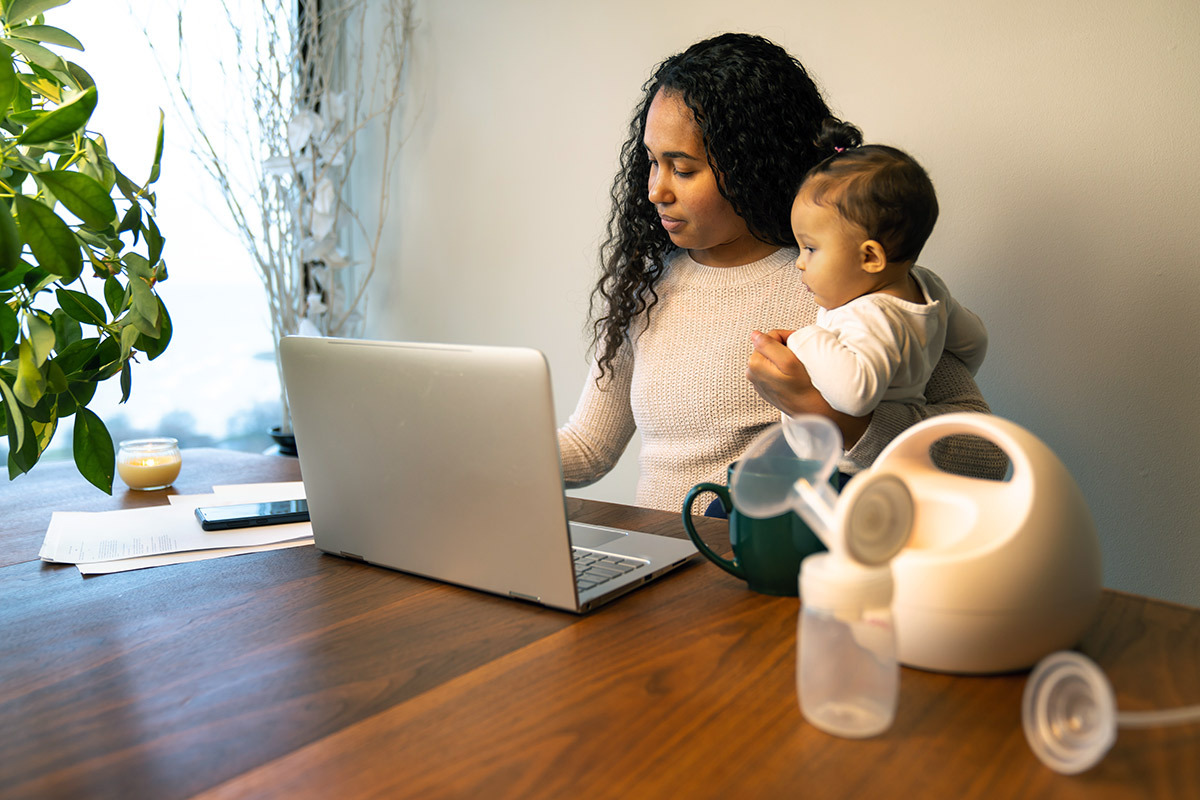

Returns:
792,193,874,308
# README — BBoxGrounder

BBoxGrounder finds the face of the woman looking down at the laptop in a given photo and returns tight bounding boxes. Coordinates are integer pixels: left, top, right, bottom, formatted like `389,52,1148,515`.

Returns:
643,90,776,266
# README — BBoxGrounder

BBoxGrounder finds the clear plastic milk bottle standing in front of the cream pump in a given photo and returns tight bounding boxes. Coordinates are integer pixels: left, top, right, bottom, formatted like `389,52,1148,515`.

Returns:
796,553,900,739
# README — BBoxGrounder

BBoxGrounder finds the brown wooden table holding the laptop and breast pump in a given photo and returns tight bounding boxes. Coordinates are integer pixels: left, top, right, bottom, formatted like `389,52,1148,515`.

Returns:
0,450,1200,799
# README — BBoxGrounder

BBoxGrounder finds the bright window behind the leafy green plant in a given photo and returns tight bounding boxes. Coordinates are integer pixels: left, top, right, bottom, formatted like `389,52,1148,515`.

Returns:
36,0,280,459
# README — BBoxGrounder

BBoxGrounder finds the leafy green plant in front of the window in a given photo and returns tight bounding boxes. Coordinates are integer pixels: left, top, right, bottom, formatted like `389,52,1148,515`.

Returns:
0,0,172,493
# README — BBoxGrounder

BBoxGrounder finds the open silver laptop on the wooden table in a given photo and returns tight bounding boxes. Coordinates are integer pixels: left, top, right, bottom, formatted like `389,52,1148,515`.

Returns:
280,336,696,613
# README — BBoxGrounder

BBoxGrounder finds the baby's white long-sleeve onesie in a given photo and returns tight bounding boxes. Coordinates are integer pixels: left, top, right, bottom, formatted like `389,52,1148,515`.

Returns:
787,266,988,416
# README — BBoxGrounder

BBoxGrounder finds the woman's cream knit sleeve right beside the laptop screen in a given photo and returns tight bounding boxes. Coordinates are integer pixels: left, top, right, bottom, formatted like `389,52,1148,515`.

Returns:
558,347,636,488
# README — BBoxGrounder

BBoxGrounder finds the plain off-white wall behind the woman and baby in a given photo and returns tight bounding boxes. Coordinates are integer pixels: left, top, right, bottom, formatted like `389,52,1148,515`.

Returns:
370,0,1200,604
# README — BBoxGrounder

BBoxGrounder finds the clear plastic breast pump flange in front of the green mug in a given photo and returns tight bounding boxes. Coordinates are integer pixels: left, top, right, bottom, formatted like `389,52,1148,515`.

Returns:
730,414,842,527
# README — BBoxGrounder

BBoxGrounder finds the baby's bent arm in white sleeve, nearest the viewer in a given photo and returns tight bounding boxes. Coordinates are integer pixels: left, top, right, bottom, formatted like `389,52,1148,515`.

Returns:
787,303,901,416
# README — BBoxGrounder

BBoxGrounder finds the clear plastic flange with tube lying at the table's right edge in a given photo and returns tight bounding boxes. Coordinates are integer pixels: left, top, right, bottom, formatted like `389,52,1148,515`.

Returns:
1021,651,1200,775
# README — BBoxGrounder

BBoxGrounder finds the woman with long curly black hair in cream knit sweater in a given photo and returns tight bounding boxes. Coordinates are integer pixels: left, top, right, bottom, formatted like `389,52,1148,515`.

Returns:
558,34,1002,511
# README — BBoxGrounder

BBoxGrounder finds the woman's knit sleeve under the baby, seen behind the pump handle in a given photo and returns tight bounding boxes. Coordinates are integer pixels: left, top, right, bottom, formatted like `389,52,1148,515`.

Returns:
842,353,1008,480
